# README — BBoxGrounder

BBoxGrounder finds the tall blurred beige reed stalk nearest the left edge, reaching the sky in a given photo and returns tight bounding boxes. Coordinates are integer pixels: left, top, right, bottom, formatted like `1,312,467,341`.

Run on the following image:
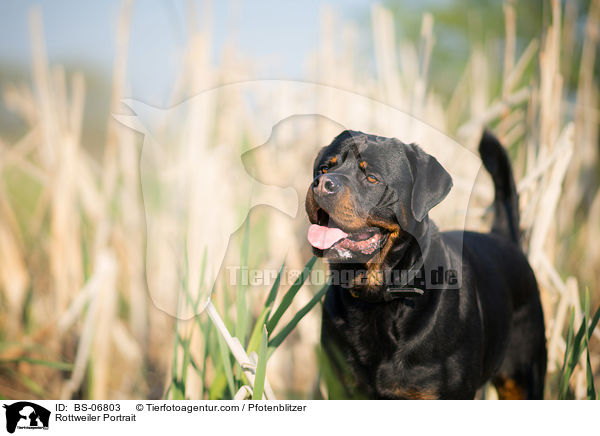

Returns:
30,5,84,313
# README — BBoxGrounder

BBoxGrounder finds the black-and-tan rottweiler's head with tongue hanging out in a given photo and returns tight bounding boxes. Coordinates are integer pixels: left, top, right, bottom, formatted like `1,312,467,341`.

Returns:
306,130,452,276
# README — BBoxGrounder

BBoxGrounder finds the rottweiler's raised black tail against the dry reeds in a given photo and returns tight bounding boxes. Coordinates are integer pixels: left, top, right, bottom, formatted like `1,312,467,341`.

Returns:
479,129,520,244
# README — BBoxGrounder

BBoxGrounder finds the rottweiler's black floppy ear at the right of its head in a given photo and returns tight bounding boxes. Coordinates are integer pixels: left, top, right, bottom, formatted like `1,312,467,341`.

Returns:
406,144,452,222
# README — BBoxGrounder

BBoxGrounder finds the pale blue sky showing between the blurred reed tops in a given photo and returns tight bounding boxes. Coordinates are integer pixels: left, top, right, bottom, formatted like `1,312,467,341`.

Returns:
0,0,370,105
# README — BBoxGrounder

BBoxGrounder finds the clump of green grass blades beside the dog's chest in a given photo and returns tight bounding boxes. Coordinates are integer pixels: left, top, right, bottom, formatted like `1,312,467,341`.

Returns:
166,257,327,400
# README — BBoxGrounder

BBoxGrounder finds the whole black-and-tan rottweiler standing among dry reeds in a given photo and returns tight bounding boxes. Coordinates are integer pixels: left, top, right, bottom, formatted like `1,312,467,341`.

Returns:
306,130,546,399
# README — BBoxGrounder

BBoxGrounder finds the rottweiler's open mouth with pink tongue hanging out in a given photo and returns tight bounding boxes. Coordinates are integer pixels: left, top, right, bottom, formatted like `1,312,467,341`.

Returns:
308,209,387,255
